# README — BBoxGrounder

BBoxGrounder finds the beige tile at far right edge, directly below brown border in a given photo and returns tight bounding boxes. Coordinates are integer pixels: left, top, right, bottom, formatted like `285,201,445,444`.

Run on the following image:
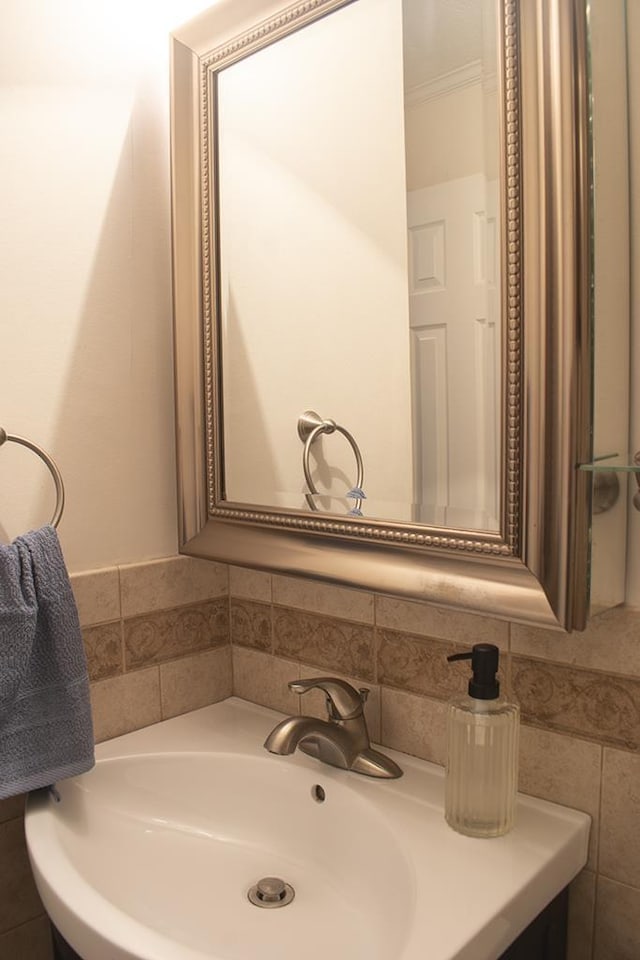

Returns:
599,748,640,888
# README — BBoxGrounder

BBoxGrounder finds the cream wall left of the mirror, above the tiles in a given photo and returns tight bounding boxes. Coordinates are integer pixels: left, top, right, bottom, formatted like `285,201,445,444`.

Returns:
0,0,211,571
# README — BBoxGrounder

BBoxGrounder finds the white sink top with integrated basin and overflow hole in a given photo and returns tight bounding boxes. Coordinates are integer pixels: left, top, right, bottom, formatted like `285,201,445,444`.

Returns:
26,698,589,960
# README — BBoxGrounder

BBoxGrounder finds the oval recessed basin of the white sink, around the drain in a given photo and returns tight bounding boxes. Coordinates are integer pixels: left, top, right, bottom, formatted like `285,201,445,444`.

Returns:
30,752,413,960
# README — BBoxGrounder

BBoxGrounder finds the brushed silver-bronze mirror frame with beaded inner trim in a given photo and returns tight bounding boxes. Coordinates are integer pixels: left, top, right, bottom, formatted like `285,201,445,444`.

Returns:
171,0,591,630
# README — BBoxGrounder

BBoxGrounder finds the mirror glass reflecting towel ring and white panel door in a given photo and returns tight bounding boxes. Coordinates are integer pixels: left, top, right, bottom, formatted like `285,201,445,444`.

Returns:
217,0,501,531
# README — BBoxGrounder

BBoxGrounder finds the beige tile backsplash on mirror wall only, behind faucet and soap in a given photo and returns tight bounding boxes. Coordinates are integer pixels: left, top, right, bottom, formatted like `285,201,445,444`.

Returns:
230,568,640,960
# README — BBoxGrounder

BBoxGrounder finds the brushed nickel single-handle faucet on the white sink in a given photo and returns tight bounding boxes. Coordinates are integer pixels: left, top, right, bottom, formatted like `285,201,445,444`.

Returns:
264,677,402,778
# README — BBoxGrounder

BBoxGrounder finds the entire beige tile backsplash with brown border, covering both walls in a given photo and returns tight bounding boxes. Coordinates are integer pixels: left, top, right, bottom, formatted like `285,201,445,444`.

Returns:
0,557,640,960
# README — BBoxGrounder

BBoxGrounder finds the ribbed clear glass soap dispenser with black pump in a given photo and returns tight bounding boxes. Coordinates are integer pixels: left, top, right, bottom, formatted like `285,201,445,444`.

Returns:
445,643,520,837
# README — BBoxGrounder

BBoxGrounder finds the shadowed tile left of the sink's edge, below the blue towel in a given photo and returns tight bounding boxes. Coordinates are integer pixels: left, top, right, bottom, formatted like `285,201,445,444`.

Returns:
0,819,43,933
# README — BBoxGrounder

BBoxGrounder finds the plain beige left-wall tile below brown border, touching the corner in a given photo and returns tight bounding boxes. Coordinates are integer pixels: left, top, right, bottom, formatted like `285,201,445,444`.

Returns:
160,646,233,720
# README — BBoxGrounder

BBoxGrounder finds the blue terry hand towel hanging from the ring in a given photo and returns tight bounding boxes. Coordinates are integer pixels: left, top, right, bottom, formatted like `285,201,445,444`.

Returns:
0,526,95,799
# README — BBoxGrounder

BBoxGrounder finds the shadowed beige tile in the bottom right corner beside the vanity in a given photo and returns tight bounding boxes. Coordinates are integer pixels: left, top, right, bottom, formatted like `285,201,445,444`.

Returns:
593,877,640,960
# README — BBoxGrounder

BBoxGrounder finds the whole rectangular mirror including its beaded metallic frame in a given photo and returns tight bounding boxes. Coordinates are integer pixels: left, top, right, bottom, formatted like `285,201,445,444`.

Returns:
172,0,591,629
